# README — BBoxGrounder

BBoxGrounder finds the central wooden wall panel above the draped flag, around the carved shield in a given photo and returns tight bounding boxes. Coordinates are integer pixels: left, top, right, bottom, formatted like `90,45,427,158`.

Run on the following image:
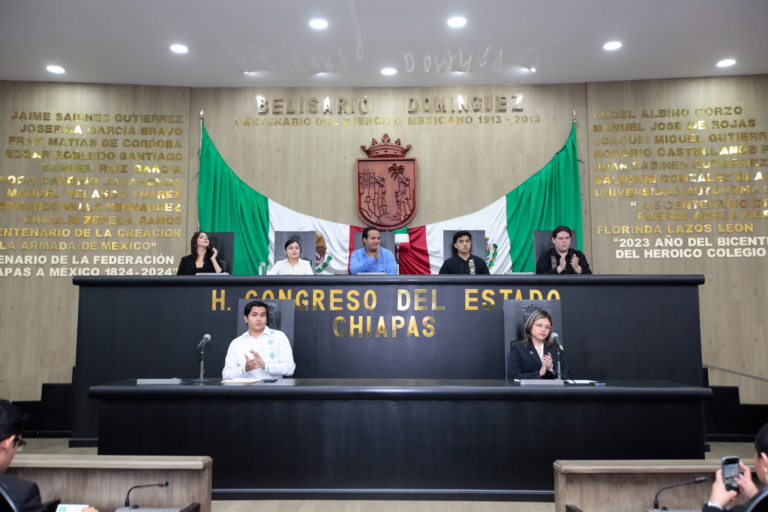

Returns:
189,84,589,241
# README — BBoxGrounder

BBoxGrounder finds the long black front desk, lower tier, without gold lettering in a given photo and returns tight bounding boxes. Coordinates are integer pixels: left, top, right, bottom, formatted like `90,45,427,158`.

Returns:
89,379,712,501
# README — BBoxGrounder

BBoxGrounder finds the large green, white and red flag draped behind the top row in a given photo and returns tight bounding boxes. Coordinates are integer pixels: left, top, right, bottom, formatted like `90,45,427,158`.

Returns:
198,125,582,275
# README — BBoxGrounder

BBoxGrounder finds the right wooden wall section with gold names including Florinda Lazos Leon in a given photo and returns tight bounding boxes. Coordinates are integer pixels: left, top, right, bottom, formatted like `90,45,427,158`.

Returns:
587,75,768,403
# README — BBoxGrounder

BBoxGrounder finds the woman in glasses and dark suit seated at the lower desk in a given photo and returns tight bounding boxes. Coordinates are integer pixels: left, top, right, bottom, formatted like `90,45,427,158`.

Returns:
507,309,573,380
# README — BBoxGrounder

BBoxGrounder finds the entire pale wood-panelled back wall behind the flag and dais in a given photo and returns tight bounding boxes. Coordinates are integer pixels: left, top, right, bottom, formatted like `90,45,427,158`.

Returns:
0,76,768,403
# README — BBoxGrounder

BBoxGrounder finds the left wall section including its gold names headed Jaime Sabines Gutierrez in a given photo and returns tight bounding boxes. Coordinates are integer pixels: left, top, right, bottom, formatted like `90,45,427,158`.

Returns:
0,82,190,399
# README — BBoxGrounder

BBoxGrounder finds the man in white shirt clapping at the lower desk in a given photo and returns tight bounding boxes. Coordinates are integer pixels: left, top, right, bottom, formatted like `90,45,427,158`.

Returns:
222,300,296,379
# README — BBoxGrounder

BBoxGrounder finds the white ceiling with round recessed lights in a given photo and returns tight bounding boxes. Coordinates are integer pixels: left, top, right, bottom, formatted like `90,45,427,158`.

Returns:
0,0,768,87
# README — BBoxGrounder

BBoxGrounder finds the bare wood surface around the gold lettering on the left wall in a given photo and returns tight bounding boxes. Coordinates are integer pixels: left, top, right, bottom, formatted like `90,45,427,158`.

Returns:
0,82,189,400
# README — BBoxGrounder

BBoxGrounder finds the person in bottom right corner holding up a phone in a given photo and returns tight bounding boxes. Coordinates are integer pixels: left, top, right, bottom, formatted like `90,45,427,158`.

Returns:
702,423,768,512
